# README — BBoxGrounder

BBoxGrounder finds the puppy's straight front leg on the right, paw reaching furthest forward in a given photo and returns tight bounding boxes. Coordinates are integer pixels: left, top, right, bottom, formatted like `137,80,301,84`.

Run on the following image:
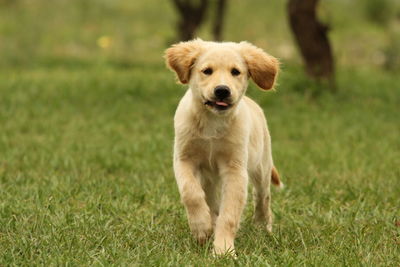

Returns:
214,162,248,255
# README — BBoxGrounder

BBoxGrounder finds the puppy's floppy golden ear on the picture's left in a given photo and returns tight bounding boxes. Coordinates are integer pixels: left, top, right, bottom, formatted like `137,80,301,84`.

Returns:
165,39,204,84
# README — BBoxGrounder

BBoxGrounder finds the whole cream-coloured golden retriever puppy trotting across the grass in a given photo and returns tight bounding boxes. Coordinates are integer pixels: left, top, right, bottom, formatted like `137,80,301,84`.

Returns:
165,39,283,255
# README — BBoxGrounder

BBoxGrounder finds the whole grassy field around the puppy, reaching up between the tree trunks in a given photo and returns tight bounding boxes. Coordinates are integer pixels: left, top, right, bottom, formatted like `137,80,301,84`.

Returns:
0,0,400,266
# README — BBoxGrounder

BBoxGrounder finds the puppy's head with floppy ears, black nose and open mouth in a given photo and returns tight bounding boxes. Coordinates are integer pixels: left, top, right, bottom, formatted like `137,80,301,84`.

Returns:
166,39,279,113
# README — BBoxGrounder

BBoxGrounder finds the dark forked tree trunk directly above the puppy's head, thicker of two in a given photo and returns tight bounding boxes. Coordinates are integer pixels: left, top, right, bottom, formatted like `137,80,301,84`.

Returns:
173,0,208,41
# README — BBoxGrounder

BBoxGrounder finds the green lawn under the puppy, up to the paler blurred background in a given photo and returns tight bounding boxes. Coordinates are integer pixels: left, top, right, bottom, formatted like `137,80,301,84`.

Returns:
0,66,400,266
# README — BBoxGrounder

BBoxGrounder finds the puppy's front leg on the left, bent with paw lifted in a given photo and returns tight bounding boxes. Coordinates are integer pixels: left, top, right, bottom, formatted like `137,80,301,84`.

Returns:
174,159,212,244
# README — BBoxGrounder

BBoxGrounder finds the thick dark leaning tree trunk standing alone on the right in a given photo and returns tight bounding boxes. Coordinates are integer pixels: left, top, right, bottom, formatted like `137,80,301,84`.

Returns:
288,0,335,90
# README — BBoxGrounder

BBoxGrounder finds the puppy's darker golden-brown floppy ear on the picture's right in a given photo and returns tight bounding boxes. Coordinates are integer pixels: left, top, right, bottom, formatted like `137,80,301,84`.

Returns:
239,42,279,90
